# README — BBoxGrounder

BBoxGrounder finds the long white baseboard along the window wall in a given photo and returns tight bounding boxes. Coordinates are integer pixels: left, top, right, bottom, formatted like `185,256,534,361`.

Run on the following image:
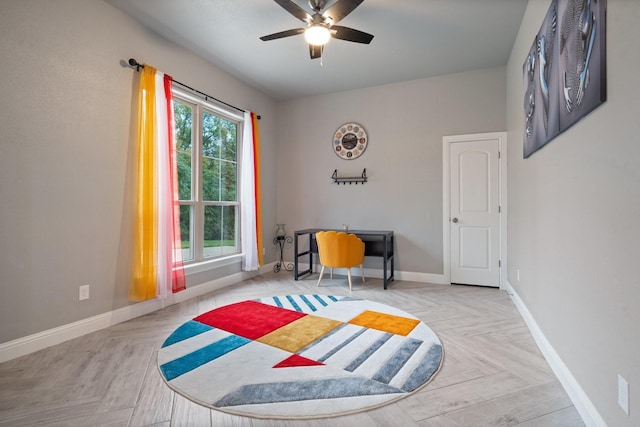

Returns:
0,263,268,363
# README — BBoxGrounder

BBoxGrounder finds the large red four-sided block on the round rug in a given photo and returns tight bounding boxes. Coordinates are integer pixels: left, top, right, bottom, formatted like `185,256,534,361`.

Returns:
193,301,306,340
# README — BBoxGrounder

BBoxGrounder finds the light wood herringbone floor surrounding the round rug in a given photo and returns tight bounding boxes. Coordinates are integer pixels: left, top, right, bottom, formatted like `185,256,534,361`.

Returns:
0,271,584,427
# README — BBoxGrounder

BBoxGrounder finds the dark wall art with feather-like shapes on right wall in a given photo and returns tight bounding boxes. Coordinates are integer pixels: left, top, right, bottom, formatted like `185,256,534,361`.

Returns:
522,0,606,158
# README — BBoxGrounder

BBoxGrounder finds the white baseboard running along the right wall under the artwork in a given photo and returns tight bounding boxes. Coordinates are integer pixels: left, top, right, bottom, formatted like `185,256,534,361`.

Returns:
504,280,607,427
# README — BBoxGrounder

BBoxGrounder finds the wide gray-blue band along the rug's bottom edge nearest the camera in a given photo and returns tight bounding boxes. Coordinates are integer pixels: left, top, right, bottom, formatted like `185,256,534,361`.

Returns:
213,377,403,407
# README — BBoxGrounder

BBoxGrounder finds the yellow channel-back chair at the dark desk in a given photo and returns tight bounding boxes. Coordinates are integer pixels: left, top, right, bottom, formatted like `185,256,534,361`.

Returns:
316,231,364,292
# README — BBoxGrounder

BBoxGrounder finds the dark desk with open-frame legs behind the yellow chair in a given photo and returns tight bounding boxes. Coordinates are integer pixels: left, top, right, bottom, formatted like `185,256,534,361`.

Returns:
293,228,394,289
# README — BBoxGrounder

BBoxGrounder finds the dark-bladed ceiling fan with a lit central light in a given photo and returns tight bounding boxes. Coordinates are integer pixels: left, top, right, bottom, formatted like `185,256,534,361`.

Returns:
260,0,373,59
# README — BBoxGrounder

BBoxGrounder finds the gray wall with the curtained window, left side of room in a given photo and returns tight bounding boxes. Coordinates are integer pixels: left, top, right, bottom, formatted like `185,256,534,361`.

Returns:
0,0,275,343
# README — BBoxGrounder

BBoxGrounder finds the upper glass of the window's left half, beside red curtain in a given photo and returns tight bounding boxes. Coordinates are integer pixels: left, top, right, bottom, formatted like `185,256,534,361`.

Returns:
173,101,193,200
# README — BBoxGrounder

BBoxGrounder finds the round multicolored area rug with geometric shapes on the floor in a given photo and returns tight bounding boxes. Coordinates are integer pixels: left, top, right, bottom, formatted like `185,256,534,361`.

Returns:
158,295,443,419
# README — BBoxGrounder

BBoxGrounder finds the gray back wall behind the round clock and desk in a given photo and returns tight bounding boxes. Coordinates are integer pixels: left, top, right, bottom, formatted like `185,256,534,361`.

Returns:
277,68,506,274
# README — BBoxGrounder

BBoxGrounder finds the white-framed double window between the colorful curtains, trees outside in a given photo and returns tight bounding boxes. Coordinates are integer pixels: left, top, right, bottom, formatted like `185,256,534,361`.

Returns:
173,88,242,263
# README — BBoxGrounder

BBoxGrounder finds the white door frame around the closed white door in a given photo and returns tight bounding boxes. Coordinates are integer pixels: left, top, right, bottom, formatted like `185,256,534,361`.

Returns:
442,132,507,289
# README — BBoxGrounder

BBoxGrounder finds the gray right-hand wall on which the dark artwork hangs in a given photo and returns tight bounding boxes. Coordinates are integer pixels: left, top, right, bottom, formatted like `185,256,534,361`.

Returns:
507,0,640,426
